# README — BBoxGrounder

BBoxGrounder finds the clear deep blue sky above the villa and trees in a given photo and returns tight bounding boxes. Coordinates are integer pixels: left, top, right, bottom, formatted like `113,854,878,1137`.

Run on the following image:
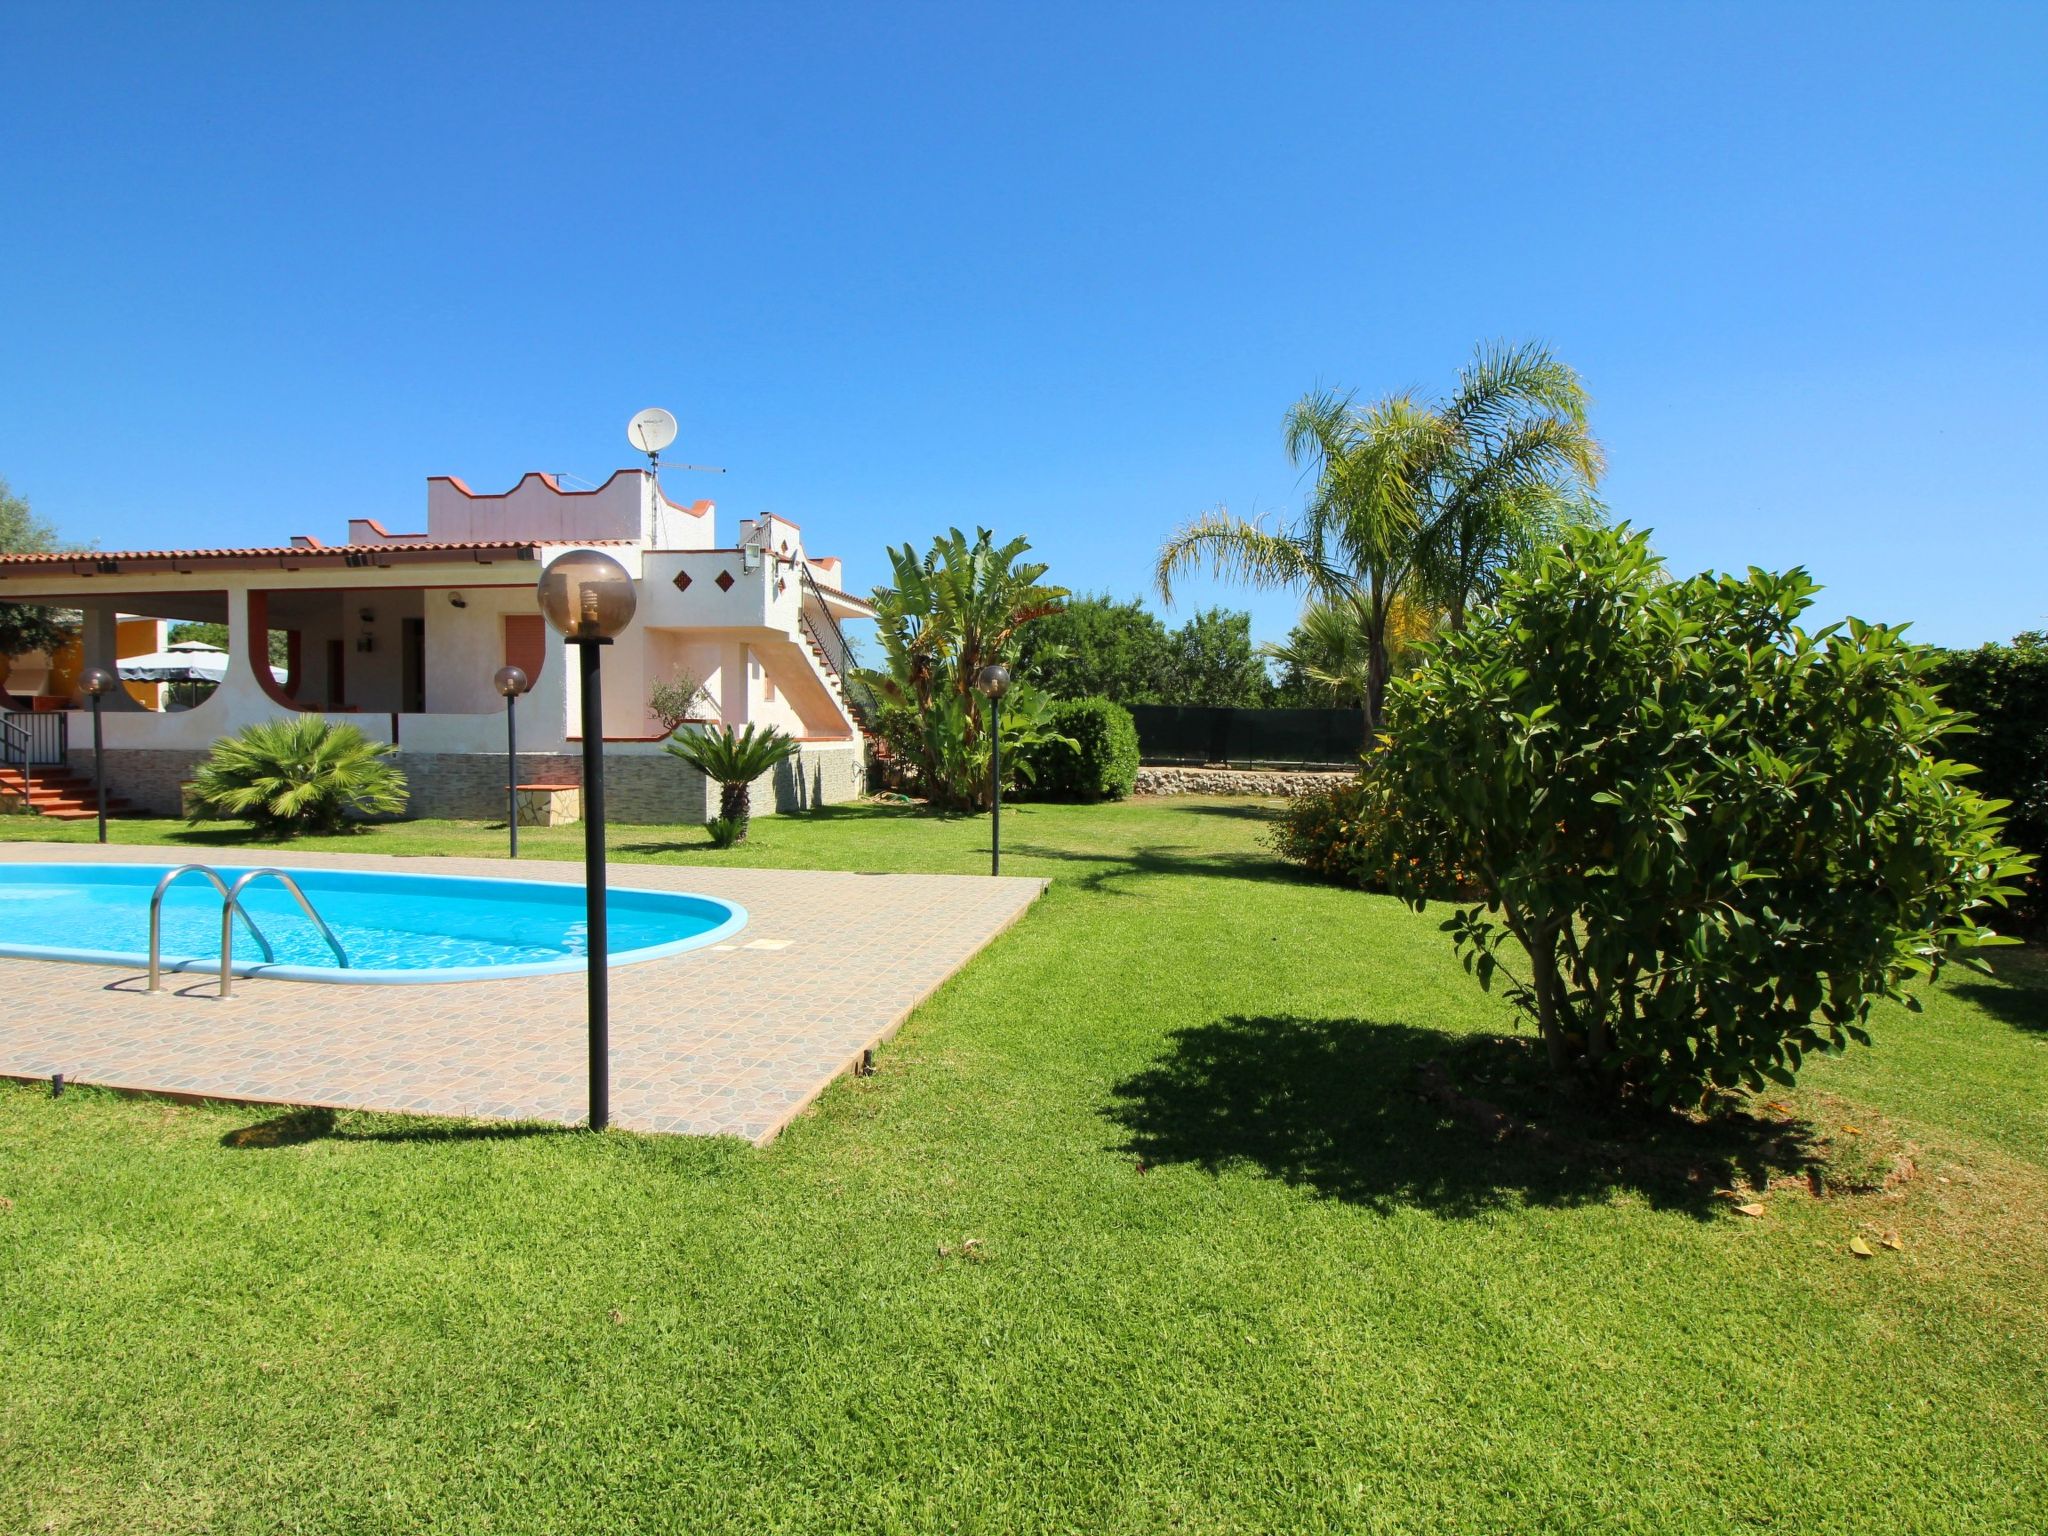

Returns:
0,2,2048,643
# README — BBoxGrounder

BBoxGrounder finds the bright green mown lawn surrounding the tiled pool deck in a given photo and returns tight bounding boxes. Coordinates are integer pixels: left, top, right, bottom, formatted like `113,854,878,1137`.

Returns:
0,801,2048,1532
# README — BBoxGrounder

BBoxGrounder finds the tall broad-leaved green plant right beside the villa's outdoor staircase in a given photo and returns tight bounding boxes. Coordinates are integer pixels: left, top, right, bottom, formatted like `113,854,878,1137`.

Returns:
860,528,1067,809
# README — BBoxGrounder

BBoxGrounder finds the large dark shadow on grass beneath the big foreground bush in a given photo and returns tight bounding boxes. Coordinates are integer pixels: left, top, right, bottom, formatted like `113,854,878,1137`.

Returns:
1104,1016,1817,1219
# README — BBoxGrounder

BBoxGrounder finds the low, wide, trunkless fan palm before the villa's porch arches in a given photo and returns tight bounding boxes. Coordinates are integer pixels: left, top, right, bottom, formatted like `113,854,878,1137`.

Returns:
193,715,406,838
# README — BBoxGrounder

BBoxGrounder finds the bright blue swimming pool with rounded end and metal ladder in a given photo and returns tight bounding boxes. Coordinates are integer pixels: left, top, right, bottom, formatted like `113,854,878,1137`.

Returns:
0,864,748,983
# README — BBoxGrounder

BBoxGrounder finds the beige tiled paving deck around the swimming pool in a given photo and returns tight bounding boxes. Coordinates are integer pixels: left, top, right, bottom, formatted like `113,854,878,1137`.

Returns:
0,844,1044,1145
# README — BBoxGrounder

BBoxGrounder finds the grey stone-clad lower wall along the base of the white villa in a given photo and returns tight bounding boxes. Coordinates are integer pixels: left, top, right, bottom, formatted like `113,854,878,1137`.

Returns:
72,741,866,825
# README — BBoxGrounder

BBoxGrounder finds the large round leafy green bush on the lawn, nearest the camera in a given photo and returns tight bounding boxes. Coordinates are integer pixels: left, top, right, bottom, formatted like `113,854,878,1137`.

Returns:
1366,528,2025,1104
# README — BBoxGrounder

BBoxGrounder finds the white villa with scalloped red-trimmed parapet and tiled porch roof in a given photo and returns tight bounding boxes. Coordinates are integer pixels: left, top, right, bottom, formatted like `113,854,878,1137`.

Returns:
0,469,872,821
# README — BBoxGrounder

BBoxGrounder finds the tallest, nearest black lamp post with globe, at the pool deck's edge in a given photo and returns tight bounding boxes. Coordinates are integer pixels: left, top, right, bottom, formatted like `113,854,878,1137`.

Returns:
539,549,639,1130
